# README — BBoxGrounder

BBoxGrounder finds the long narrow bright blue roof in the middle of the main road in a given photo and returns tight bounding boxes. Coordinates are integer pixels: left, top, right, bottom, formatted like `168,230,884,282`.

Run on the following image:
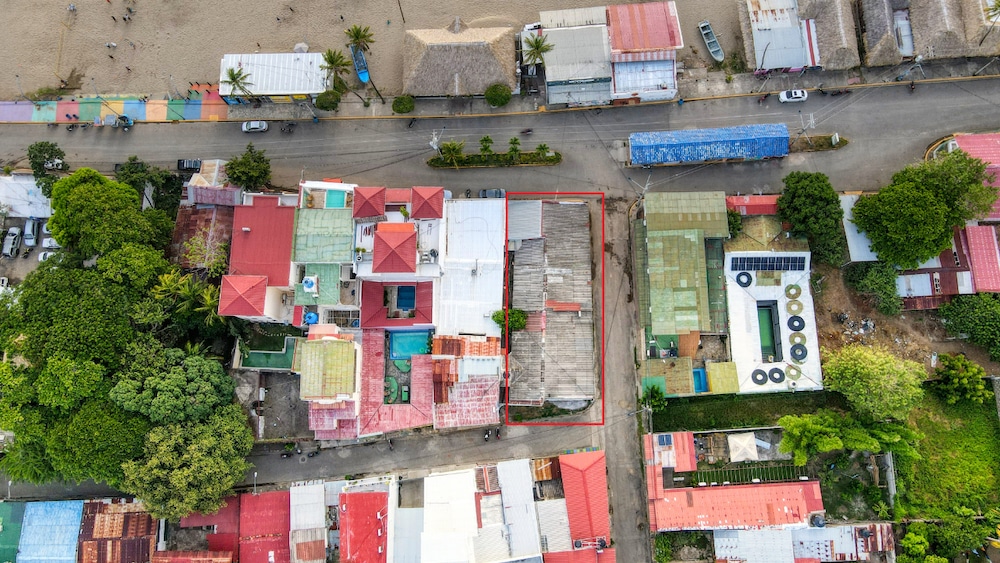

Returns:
628,123,788,166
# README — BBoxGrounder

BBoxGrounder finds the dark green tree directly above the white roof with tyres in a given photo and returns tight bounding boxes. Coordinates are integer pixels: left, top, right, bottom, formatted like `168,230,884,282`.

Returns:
778,172,847,266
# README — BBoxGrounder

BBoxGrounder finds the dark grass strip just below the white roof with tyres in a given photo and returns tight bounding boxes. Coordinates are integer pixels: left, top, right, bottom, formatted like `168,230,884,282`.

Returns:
653,391,847,432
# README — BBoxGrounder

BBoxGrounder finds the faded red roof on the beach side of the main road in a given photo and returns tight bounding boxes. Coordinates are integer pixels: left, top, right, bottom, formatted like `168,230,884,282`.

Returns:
608,2,684,58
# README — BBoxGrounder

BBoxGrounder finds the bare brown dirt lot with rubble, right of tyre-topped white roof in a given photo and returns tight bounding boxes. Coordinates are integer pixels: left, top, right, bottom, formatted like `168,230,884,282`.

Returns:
813,266,1000,373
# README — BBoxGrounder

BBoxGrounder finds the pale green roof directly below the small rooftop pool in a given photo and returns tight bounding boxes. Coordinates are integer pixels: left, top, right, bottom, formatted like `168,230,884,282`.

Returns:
292,209,354,264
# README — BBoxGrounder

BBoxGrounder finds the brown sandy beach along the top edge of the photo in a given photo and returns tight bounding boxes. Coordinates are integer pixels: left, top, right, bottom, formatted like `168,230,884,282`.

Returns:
0,0,739,99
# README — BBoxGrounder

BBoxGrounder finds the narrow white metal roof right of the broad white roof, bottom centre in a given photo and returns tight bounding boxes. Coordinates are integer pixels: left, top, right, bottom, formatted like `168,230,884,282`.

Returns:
497,459,541,557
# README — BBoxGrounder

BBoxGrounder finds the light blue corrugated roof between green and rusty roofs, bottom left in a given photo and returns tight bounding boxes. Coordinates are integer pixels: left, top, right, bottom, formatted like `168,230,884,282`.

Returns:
17,500,83,563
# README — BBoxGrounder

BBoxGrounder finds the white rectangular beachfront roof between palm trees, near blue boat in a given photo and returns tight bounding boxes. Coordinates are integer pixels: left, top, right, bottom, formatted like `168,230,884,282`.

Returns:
219,53,326,96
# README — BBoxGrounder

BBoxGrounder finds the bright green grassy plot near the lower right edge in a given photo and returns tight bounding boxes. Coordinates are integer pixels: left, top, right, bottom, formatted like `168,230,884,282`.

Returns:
899,393,1000,518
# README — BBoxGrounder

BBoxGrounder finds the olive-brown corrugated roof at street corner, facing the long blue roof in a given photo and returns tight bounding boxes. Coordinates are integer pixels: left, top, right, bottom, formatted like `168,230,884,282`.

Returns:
644,192,729,238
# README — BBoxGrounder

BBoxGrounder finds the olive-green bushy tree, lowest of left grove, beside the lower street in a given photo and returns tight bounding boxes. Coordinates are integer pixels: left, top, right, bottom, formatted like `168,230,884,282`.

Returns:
122,405,253,521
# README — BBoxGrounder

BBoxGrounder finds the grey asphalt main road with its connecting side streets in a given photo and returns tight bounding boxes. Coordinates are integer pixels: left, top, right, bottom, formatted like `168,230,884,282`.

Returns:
0,80,1000,561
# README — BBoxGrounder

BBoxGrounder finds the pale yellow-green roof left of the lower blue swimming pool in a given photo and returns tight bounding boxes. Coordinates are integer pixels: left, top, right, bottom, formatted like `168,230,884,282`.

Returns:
292,338,355,401
